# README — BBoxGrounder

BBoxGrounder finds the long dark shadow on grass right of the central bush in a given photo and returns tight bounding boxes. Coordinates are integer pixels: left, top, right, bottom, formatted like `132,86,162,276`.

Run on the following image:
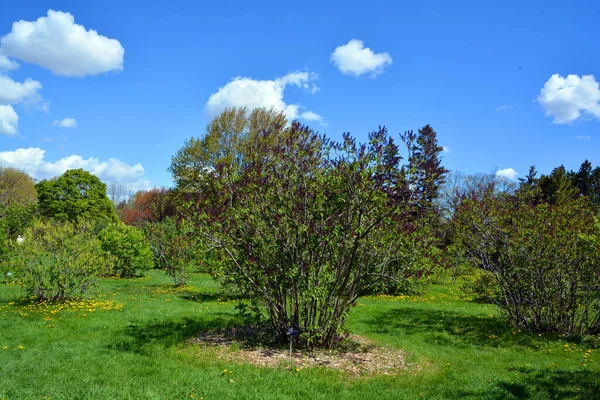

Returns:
364,308,549,348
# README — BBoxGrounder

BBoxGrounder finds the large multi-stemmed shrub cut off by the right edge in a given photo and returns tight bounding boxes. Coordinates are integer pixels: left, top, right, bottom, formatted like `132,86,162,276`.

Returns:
457,197,600,335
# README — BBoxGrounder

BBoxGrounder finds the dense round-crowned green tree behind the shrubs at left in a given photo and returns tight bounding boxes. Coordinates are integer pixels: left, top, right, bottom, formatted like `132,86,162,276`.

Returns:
36,169,119,223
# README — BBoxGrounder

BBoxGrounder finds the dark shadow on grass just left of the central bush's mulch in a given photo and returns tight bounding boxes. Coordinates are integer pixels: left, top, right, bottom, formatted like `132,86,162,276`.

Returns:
109,318,241,354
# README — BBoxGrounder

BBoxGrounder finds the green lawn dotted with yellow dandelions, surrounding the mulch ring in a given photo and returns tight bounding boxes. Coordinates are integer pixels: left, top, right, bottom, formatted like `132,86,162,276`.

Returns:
0,271,600,400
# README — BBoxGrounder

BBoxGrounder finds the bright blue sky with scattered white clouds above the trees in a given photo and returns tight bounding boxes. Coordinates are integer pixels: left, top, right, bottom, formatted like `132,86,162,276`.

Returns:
0,0,600,194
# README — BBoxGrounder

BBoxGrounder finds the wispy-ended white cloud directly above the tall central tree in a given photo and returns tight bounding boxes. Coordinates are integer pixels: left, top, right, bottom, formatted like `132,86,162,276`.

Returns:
205,72,321,121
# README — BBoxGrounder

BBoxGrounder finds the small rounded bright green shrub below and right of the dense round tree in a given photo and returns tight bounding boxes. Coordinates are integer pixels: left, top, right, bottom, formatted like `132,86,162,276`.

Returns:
99,223,153,278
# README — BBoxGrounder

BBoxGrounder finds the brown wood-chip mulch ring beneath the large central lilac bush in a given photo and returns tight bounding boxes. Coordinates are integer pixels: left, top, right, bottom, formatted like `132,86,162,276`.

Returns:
191,327,408,376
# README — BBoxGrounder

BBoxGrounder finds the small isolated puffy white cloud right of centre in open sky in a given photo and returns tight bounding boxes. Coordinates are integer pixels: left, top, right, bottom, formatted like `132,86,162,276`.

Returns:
331,39,392,76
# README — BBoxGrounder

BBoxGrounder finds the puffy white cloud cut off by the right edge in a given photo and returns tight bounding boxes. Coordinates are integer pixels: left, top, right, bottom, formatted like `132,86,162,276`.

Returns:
537,74,600,124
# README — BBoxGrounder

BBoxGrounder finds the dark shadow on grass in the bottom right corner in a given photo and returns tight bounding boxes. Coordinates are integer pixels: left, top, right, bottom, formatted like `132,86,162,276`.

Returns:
486,369,600,400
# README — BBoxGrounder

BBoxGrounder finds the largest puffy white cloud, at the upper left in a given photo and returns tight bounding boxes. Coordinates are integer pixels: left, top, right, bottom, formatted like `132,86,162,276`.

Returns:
0,10,125,76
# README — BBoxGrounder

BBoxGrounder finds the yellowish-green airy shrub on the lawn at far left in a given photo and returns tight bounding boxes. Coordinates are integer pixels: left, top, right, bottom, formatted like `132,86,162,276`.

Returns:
3,221,112,302
